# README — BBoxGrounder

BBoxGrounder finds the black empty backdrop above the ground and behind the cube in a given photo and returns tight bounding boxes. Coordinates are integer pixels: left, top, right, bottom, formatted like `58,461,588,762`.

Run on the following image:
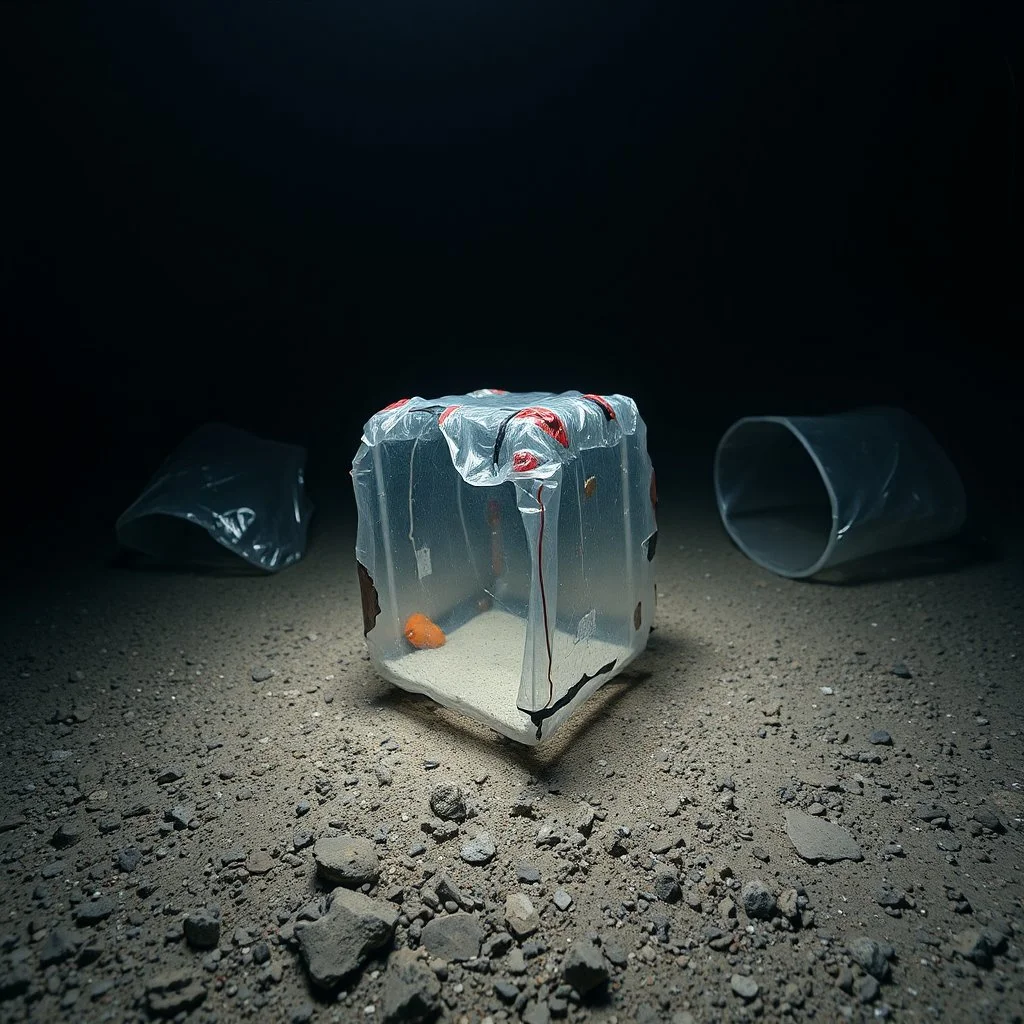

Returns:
0,0,1024,552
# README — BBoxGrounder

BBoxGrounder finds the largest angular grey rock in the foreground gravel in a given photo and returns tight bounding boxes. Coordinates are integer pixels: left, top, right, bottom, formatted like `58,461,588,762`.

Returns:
295,889,398,989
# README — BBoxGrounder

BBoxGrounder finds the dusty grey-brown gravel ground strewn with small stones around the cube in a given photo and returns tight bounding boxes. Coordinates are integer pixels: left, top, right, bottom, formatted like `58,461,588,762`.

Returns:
0,479,1024,1024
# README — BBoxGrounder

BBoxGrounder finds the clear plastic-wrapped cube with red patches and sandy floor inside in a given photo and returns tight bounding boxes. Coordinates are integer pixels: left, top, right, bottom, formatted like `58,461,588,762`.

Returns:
352,390,657,744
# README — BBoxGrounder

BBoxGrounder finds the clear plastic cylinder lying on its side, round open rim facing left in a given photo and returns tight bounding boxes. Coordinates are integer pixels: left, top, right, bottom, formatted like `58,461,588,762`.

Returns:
715,408,967,578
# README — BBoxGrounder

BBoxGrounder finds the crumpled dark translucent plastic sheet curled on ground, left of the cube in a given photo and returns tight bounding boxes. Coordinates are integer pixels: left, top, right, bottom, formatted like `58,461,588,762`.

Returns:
116,423,312,572
